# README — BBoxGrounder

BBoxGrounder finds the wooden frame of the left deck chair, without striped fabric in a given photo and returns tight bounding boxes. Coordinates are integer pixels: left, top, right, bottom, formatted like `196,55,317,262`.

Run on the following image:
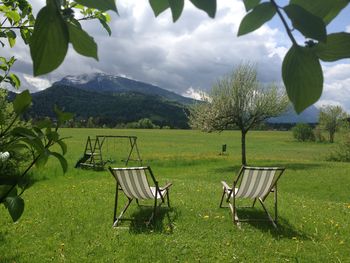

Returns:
108,166,172,227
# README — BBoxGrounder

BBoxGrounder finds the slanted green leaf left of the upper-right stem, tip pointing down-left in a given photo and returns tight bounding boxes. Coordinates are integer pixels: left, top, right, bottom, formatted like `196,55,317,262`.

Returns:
238,2,276,36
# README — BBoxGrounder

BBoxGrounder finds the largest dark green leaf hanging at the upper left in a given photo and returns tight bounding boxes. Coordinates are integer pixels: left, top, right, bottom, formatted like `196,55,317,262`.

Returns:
29,5,69,76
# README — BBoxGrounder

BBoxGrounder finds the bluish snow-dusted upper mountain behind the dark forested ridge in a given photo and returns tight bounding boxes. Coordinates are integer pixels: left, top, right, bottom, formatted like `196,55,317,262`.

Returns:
53,73,195,104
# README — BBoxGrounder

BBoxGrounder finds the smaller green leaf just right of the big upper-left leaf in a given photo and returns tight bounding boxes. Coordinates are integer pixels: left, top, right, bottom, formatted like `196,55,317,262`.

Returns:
67,23,98,61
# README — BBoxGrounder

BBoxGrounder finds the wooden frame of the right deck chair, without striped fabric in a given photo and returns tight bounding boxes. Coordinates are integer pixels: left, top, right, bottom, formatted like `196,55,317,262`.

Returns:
220,166,285,228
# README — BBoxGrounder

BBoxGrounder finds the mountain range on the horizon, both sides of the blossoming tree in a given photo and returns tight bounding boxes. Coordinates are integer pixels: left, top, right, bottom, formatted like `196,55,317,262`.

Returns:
5,73,318,128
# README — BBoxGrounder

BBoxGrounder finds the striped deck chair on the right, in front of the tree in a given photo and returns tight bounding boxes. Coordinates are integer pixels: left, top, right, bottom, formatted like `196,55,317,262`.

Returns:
220,166,285,228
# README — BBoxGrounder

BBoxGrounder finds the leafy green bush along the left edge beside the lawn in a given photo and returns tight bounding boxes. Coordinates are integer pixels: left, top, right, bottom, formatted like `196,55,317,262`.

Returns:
0,90,70,221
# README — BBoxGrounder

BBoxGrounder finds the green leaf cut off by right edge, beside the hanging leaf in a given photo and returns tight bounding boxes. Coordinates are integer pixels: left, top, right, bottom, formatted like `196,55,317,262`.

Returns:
315,32,350,61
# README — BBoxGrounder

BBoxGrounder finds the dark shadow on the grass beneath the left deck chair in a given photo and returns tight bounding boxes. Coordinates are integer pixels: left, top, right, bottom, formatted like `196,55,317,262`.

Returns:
116,206,179,235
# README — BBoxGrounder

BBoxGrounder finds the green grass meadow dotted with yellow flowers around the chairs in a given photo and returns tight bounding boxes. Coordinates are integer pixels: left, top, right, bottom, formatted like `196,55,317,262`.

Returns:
0,129,350,262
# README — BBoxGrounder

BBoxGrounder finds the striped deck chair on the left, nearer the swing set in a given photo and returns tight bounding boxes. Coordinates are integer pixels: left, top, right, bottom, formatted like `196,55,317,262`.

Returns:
109,167,172,227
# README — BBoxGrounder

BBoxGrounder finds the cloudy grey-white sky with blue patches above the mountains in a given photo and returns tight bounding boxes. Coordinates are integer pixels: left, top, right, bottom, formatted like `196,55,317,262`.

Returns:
2,0,350,112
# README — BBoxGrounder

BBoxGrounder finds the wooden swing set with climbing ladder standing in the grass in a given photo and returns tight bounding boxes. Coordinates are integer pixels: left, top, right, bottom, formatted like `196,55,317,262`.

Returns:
75,135,142,170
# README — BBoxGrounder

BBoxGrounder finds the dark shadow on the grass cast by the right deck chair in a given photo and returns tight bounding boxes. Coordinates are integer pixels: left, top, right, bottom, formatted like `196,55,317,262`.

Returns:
238,208,313,240
